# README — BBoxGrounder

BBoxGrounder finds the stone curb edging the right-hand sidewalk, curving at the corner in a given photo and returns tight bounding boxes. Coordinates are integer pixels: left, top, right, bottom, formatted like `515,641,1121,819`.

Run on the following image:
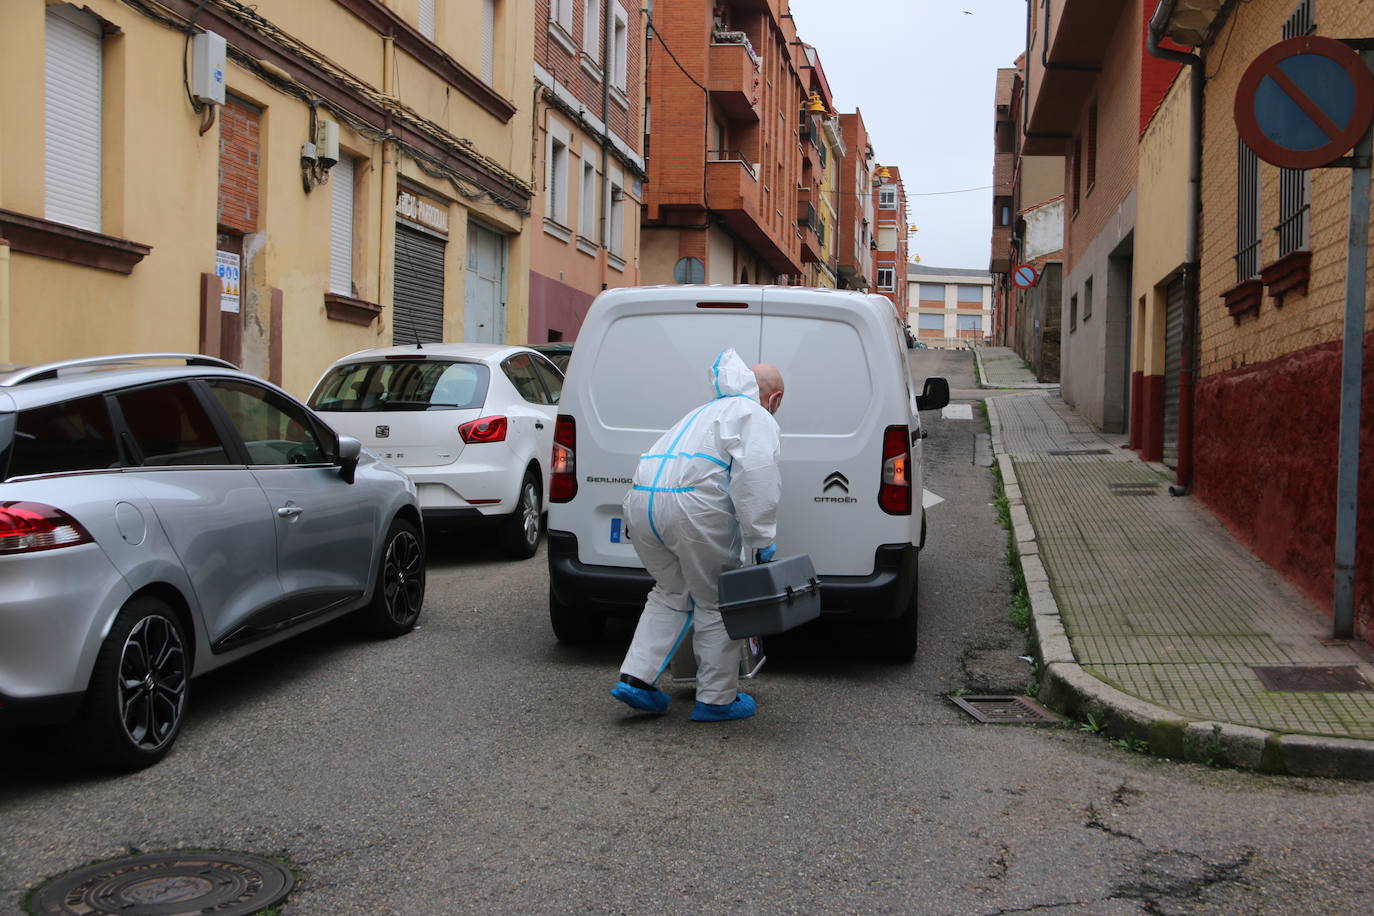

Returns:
980,395,1374,780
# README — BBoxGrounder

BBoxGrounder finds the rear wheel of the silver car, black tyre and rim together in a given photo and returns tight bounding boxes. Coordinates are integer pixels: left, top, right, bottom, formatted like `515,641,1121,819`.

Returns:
70,596,191,770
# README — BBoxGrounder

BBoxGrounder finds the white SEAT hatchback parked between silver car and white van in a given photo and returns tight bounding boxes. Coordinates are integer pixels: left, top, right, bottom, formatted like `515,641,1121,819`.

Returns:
309,343,563,559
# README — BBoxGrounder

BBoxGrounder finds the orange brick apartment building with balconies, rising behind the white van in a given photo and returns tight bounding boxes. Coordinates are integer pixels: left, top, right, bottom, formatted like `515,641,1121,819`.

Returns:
640,0,820,283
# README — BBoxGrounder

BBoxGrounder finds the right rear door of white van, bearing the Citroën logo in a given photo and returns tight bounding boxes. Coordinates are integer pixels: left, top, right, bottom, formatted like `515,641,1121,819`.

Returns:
760,287,919,575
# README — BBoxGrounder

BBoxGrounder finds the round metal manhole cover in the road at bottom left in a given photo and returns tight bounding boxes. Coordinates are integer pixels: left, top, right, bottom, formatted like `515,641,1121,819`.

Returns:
33,851,293,916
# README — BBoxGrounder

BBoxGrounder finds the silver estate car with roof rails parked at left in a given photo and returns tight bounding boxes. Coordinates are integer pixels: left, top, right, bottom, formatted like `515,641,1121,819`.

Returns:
0,354,425,769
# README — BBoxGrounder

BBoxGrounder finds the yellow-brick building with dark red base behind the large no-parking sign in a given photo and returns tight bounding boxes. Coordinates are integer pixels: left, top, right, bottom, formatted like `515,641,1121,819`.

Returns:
1161,0,1374,643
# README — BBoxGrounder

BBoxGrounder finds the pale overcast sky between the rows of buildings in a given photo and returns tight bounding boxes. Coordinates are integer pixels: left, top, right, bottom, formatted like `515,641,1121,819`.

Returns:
791,0,1026,271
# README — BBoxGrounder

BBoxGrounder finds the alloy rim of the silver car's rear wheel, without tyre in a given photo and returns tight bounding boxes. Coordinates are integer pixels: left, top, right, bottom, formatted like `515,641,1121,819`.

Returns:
120,614,187,751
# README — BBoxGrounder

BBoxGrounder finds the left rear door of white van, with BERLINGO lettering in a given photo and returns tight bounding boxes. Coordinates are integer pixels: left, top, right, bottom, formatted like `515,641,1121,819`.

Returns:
563,286,763,566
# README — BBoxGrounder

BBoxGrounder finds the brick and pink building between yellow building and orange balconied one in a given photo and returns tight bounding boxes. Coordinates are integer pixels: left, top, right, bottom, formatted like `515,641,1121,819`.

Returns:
528,0,647,342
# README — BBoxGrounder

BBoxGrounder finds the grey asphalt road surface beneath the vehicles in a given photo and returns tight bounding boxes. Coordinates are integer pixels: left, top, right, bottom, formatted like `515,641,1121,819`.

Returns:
0,350,1374,916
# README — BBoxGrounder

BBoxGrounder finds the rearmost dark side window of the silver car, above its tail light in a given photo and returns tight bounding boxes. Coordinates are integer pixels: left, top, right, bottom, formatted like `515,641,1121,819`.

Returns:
0,397,121,477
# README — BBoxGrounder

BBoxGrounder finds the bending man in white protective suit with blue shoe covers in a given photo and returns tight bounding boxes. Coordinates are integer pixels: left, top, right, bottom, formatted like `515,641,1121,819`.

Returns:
611,349,783,722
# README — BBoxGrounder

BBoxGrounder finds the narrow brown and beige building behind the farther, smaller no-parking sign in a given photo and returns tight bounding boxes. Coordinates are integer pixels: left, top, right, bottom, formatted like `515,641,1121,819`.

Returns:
988,54,1063,382
